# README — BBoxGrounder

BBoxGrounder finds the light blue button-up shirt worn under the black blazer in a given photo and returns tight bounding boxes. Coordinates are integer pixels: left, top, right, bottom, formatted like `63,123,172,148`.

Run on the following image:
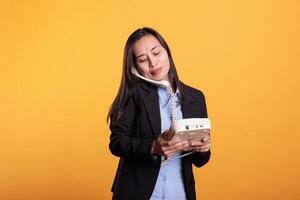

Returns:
150,87,186,200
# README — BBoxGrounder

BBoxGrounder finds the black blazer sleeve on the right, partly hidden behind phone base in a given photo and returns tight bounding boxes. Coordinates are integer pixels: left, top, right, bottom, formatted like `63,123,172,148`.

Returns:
190,91,211,167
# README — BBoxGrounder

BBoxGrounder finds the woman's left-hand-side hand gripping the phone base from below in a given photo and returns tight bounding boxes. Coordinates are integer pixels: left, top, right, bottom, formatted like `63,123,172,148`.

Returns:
152,128,189,157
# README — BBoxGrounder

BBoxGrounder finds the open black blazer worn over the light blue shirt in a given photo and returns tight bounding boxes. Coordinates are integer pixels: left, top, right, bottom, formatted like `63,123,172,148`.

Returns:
109,82,210,200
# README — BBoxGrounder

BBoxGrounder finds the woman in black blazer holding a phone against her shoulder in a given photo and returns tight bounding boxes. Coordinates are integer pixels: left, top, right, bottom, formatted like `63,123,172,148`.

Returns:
108,28,211,200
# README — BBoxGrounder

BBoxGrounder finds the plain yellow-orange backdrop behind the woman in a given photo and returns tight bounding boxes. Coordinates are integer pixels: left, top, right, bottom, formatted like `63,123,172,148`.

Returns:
0,0,300,200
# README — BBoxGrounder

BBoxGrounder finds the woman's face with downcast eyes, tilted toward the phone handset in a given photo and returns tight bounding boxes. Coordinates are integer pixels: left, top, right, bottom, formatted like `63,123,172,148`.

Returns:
133,35,170,81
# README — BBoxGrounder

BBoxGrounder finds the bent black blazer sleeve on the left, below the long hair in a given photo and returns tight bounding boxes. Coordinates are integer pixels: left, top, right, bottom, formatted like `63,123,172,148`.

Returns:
109,95,153,160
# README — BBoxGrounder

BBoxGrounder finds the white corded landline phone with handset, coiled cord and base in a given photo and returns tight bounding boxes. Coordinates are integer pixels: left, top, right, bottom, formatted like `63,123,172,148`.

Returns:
132,67,211,165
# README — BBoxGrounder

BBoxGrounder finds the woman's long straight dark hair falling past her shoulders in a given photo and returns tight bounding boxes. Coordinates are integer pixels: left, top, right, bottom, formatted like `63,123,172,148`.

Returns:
106,27,181,123
